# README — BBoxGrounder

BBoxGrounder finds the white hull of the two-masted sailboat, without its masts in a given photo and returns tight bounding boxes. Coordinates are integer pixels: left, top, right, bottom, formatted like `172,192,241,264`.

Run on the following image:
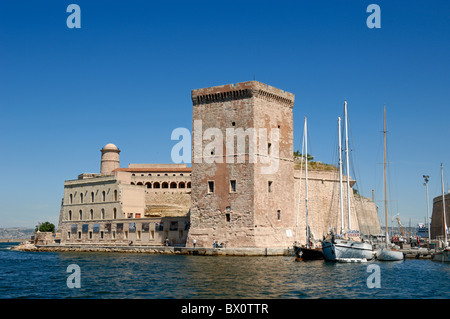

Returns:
322,239,374,261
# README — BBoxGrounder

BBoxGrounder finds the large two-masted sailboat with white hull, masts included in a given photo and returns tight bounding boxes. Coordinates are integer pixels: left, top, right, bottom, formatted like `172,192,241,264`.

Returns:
322,101,374,262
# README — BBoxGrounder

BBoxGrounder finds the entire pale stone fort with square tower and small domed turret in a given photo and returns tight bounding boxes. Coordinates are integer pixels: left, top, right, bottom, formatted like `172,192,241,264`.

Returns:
58,81,381,247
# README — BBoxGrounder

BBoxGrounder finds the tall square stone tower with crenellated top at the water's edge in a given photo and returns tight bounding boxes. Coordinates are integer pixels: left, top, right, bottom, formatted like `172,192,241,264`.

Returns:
187,81,296,247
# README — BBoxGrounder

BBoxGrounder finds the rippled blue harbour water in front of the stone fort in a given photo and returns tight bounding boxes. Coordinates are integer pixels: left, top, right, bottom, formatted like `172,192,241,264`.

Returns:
0,243,450,299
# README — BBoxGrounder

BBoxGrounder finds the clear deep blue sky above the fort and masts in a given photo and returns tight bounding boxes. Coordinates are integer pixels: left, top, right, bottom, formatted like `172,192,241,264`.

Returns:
0,0,450,227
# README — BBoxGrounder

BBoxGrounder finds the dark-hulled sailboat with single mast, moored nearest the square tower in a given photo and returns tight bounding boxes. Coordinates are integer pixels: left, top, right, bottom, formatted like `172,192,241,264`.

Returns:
294,116,324,260
